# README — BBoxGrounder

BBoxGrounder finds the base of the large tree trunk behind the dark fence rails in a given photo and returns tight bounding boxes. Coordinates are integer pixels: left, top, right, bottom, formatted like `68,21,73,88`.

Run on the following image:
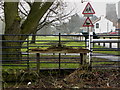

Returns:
2,36,22,63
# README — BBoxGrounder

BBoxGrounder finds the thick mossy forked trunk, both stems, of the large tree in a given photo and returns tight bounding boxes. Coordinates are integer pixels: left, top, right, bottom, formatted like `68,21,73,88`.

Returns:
2,2,53,63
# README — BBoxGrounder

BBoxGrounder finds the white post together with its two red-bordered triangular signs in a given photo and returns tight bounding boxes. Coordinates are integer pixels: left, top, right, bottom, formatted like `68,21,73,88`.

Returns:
82,2,95,65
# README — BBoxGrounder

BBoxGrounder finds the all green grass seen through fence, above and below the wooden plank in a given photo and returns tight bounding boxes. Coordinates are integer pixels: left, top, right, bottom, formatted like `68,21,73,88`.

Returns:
2,36,120,69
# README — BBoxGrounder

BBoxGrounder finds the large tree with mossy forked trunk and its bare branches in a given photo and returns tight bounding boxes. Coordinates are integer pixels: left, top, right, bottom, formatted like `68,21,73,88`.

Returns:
0,0,74,60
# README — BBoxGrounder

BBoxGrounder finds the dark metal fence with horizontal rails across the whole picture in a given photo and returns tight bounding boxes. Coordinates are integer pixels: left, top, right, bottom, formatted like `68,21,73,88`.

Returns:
0,34,120,70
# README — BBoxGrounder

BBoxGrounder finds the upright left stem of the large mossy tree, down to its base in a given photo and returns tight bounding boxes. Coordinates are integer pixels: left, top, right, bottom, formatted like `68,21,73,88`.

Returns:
2,2,22,63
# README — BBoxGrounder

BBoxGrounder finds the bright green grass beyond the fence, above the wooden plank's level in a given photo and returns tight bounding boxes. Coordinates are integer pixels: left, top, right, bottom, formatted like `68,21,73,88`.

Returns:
22,36,120,55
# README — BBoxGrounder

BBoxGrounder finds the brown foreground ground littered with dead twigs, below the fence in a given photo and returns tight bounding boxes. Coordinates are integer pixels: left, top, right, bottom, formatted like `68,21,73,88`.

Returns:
5,69,120,90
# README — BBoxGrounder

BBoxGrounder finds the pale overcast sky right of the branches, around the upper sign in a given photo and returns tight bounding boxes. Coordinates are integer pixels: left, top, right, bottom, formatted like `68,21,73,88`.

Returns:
65,0,120,17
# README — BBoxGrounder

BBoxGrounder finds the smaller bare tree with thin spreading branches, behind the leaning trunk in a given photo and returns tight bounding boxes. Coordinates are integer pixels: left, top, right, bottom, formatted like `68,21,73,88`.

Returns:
31,1,73,43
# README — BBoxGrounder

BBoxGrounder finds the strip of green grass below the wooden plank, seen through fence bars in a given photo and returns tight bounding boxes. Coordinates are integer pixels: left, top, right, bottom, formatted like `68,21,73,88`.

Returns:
2,55,117,70
